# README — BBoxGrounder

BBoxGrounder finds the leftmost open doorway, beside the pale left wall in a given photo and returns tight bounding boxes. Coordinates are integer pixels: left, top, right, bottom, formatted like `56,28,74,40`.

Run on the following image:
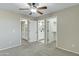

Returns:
21,19,28,41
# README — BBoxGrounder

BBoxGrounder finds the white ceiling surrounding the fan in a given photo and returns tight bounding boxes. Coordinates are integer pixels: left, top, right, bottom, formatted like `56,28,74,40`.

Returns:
0,3,78,17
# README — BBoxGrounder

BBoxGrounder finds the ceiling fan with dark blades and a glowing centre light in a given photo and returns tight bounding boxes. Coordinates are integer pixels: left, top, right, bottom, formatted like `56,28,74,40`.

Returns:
19,3,47,15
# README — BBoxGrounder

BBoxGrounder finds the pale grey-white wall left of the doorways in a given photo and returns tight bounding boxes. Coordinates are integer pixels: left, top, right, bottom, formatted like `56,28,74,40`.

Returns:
0,10,21,49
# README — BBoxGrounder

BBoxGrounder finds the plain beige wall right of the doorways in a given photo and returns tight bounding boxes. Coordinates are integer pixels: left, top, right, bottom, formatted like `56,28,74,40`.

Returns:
53,5,79,54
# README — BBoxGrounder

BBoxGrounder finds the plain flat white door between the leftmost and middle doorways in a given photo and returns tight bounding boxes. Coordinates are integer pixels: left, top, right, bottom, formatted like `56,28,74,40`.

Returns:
29,20,37,42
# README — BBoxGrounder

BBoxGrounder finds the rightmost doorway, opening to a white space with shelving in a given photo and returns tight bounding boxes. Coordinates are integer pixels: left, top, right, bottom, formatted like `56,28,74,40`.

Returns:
47,17,57,43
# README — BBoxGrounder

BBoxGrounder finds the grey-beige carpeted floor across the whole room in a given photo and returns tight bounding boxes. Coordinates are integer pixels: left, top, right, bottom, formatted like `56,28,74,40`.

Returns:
0,40,78,56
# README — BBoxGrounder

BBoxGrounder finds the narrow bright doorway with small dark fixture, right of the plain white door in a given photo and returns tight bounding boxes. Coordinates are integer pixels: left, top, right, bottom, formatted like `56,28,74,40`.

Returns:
38,20,45,43
